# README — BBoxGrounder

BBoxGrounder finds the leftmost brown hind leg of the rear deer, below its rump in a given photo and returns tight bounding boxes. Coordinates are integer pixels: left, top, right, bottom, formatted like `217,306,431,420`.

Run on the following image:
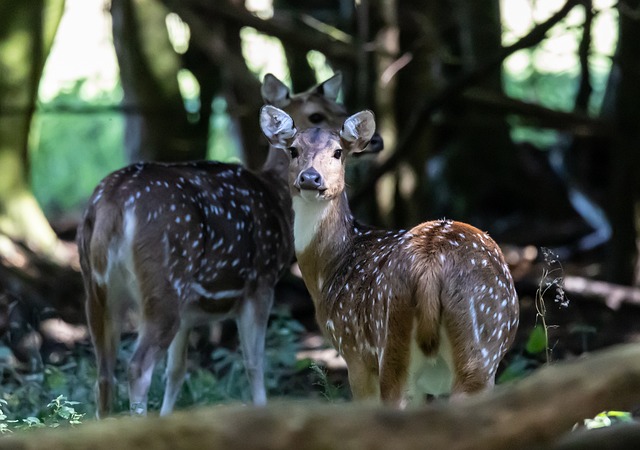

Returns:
86,280,120,418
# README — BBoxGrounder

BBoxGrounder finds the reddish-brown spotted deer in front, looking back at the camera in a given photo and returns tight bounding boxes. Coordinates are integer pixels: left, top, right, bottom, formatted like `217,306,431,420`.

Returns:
260,106,519,407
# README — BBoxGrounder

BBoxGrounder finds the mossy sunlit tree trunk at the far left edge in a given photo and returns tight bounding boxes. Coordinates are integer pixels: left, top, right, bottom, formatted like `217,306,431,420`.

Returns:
0,0,64,256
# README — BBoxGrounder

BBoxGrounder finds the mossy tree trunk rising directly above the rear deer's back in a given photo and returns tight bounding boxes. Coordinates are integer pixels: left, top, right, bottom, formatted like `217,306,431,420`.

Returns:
111,0,206,162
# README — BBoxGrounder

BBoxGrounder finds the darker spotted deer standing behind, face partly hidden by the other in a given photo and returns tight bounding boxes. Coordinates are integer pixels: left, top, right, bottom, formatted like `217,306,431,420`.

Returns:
78,74,380,417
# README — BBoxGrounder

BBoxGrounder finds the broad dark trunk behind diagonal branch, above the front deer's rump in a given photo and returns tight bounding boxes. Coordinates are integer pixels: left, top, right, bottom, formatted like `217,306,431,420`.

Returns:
438,0,521,227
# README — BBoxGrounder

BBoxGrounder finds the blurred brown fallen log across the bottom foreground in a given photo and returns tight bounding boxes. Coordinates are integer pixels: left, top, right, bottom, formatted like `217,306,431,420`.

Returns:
0,345,640,450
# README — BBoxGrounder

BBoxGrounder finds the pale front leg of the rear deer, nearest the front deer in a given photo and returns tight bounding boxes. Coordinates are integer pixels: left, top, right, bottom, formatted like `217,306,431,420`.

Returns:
236,288,273,405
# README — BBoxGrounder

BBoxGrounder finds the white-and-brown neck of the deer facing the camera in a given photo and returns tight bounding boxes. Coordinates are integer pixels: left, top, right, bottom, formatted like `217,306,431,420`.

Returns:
293,193,355,301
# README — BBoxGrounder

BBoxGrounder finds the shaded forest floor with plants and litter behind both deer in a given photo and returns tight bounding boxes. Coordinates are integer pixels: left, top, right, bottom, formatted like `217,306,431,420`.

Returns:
0,234,640,417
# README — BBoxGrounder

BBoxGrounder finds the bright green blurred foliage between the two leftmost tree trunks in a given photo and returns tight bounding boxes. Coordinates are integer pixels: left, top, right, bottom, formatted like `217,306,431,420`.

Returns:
31,80,125,214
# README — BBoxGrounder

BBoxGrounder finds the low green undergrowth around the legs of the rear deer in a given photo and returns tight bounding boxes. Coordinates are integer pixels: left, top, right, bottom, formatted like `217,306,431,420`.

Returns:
0,308,329,420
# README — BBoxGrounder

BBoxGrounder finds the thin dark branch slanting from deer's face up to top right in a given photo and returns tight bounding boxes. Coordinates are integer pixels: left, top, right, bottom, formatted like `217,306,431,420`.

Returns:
351,0,584,204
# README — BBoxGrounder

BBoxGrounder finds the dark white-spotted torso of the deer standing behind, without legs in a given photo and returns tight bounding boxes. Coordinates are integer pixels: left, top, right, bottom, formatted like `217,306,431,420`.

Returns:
79,162,293,310
